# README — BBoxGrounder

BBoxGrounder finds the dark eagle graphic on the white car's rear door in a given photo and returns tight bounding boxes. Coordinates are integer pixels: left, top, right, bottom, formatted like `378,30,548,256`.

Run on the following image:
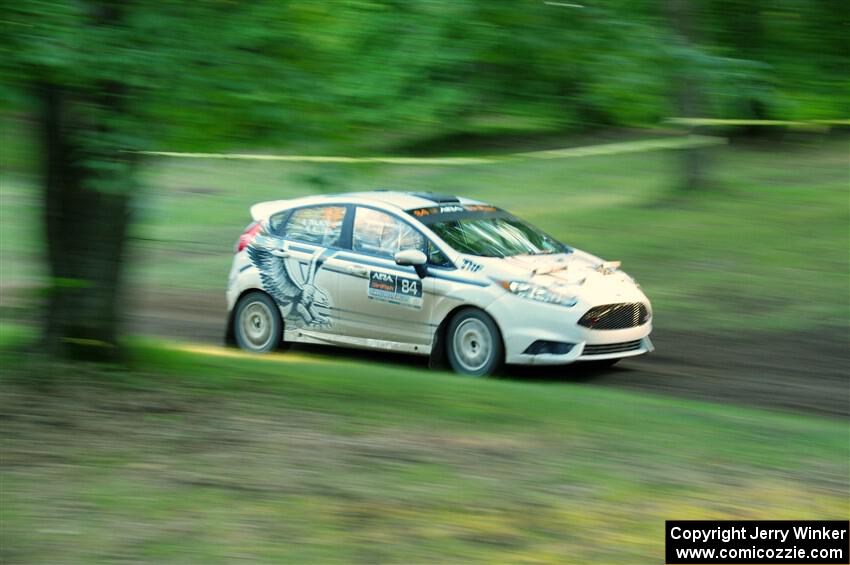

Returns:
248,236,331,328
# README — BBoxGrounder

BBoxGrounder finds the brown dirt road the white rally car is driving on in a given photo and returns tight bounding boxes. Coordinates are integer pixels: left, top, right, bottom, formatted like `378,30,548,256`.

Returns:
129,292,850,417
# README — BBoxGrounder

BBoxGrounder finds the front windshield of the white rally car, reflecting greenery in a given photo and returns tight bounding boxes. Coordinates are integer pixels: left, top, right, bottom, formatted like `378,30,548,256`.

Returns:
428,216,567,257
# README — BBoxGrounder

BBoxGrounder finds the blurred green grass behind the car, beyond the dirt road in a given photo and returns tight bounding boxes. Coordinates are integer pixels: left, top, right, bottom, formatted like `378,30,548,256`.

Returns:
0,121,850,332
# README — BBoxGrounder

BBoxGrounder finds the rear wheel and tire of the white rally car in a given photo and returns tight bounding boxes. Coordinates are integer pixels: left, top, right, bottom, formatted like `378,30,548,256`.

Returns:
233,291,283,353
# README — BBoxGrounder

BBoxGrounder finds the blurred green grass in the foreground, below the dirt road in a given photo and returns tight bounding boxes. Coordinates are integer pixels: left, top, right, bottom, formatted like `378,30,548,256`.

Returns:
0,342,850,563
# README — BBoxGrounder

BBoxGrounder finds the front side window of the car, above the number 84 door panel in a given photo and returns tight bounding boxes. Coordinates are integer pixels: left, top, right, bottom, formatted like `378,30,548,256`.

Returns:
351,207,425,259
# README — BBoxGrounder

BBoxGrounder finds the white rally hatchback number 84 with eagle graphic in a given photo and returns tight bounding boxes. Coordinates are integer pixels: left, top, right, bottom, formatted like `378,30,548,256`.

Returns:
222,191,653,375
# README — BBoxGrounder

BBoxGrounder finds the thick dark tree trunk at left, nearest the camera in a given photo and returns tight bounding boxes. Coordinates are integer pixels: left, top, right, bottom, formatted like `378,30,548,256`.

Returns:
37,84,130,360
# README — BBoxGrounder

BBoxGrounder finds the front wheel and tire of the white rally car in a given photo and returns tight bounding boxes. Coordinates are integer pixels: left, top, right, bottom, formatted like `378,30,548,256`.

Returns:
446,308,505,377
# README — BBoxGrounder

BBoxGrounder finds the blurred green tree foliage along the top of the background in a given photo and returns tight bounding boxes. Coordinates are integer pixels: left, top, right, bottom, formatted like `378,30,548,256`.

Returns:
0,0,850,150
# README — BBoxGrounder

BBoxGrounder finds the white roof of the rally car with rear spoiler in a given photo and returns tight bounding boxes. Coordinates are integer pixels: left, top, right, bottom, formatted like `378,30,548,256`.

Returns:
251,190,485,220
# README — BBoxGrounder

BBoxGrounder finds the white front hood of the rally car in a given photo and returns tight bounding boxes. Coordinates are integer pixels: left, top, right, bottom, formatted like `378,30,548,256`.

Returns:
462,249,646,303
